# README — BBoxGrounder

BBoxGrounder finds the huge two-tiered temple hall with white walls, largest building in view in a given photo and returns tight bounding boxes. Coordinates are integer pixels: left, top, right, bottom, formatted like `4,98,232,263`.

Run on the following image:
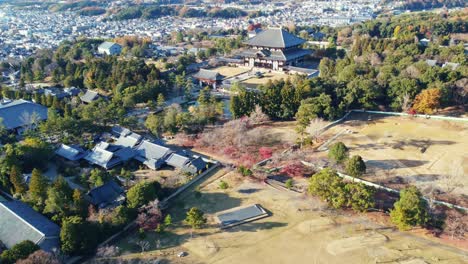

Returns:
239,28,312,71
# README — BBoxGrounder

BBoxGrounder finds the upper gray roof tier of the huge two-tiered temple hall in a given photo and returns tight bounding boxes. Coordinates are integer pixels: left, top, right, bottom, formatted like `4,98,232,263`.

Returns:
245,28,305,48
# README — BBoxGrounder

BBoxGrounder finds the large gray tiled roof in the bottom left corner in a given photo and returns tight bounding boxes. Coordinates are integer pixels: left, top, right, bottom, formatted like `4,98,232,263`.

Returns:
0,201,60,251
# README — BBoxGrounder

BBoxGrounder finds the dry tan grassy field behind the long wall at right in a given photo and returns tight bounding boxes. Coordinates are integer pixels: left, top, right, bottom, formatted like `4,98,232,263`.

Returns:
323,113,468,201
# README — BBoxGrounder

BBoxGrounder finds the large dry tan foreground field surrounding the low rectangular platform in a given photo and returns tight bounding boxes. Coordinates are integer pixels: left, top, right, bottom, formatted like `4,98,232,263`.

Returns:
104,170,468,264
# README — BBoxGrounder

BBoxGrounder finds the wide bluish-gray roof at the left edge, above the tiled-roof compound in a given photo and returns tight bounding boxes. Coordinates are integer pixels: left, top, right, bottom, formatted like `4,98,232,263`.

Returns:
0,100,47,129
